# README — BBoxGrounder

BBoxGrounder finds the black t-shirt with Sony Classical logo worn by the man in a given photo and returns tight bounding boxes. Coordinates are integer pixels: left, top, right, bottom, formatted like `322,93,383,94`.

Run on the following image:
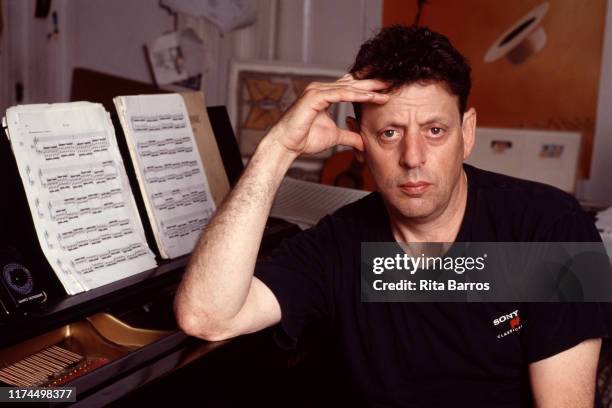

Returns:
255,165,608,407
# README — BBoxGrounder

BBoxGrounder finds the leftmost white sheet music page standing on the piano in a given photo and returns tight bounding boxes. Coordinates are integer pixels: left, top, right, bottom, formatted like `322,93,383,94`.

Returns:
7,102,157,294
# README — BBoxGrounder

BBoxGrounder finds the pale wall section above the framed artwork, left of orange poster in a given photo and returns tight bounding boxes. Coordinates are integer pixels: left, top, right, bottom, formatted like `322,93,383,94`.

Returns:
179,0,382,105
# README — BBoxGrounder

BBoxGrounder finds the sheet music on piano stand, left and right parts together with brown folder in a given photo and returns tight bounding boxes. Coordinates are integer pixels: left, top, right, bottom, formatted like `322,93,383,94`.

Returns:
3,93,229,294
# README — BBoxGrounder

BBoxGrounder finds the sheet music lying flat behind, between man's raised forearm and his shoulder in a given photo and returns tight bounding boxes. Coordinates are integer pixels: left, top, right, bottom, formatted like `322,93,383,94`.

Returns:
270,177,370,229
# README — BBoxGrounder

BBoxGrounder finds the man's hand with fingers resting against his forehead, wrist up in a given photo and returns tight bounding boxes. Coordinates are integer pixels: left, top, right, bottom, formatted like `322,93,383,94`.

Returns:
266,74,389,156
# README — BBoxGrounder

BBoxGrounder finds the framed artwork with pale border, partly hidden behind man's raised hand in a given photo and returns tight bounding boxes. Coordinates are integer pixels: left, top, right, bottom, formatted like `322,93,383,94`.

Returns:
228,60,352,161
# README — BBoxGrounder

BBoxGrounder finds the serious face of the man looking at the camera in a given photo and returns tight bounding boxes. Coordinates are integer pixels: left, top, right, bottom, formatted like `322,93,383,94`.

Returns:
360,83,475,221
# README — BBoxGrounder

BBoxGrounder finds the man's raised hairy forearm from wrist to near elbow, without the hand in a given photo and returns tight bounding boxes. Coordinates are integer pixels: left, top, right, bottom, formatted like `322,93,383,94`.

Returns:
176,137,295,321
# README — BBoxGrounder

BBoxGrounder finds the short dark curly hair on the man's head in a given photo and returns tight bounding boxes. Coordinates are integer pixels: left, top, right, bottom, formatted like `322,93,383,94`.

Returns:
349,25,472,121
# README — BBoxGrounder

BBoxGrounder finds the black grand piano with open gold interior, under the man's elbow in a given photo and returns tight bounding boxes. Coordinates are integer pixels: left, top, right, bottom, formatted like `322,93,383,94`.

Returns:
0,70,334,407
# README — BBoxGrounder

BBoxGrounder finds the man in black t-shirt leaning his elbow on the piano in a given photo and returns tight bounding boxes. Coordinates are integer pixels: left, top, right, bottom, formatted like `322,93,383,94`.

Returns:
175,26,605,407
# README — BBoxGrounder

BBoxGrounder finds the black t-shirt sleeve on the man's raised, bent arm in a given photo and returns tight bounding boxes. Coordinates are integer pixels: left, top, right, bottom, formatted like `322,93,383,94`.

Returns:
255,217,334,348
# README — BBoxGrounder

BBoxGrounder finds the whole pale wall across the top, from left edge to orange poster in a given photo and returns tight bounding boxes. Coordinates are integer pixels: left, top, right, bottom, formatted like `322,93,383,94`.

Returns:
0,0,382,105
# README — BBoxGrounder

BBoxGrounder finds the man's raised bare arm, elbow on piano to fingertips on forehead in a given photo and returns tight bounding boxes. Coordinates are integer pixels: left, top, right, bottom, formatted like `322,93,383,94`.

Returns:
175,75,382,340
